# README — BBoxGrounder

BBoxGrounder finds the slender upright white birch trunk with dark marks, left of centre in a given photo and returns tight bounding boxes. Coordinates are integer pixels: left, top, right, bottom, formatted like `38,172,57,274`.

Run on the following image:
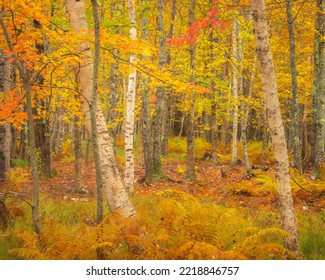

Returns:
125,0,137,194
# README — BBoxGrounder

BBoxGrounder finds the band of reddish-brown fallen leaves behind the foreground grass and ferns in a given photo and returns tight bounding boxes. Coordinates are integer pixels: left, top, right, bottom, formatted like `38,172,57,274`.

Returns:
36,156,325,212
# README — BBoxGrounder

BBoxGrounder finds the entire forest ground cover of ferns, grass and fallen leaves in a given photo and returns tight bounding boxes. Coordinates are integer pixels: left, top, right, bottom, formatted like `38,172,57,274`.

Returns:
0,138,325,259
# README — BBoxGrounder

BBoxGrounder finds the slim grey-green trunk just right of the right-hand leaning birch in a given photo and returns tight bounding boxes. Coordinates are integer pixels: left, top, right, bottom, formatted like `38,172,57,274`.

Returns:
286,0,302,172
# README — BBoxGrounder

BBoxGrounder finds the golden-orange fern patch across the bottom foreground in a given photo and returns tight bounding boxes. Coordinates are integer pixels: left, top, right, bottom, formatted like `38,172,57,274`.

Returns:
3,189,295,260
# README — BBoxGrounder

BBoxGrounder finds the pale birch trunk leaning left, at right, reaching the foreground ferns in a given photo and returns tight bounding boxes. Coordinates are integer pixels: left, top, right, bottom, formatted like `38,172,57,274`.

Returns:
252,0,300,256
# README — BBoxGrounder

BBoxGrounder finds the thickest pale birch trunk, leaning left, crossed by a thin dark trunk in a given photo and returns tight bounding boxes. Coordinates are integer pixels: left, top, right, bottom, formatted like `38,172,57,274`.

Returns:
66,0,135,216
